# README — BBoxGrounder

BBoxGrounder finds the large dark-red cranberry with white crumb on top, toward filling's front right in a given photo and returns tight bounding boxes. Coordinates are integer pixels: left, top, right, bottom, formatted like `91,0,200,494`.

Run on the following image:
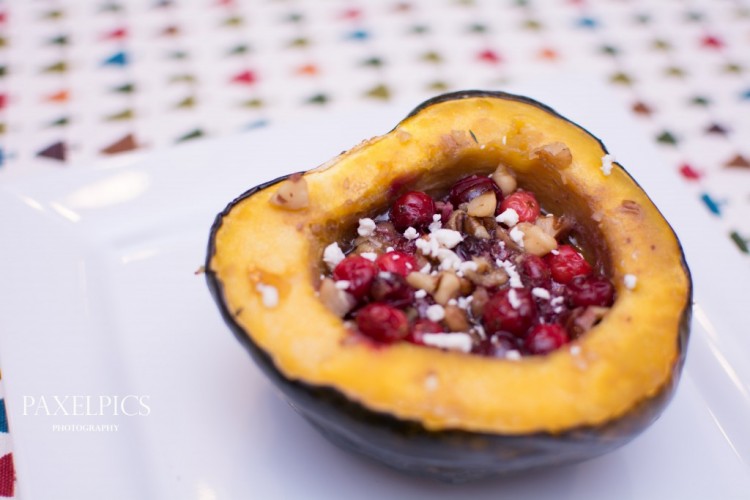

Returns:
482,288,537,337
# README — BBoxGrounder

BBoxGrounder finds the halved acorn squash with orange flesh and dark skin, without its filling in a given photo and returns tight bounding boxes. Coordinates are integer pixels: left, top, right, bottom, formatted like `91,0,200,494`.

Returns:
205,91,692,482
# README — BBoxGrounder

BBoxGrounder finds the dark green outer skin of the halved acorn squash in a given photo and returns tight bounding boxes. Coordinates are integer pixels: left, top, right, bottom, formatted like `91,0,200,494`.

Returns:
205,91,692,482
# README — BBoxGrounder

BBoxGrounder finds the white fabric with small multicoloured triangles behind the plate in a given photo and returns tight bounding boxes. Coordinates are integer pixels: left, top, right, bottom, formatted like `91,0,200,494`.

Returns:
0,0,750,494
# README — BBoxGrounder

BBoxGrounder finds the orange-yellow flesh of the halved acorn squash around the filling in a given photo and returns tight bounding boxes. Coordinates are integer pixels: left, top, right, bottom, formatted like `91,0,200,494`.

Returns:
209,97,690,435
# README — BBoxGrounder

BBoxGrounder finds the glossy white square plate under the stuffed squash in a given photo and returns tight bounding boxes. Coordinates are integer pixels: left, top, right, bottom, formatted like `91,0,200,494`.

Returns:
0,80,750,500
